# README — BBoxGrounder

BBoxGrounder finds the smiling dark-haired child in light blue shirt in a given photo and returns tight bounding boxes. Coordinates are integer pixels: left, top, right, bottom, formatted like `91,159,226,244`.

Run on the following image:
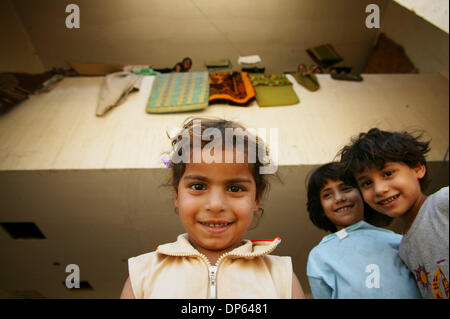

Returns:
307,163,421,299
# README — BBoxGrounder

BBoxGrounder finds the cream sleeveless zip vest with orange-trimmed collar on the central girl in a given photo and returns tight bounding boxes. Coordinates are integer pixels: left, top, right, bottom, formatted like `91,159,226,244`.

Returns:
128,234,292,299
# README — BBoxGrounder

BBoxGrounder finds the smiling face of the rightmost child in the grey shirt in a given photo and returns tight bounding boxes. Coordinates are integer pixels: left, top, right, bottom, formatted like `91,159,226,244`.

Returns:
355,162,426,228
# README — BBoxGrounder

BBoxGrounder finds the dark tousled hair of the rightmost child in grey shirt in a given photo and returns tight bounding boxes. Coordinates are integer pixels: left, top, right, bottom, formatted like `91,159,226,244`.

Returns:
339,128,430,192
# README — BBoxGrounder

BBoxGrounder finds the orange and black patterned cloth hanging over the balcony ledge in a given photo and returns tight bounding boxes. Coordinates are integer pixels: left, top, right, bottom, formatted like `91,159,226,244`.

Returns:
209,72,256,105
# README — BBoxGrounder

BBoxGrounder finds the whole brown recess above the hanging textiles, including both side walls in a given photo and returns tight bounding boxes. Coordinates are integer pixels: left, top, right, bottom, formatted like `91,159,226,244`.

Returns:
0,0,449,78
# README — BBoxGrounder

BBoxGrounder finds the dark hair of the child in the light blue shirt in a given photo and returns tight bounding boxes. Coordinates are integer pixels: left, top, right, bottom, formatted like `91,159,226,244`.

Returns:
306,162,392,233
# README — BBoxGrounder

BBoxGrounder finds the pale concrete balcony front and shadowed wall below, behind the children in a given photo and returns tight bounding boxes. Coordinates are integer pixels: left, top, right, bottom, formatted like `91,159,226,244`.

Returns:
0,74,449,298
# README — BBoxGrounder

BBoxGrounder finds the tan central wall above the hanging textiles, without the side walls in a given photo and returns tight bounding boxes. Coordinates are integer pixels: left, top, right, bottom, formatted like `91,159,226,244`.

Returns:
7,0,388,72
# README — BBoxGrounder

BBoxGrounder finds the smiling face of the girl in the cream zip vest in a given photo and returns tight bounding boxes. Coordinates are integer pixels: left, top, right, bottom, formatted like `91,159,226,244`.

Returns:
175,153,258,262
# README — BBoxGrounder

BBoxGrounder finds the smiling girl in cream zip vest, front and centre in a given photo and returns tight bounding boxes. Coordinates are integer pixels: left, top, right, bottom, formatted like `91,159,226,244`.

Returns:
121,119,304,299
